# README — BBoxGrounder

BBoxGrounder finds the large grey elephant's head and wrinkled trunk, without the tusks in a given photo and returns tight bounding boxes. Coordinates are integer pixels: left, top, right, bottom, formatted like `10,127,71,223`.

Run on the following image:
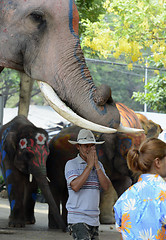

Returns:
0,0,120,128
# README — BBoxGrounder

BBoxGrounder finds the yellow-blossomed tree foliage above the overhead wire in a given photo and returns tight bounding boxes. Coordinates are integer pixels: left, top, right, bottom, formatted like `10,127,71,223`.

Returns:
82,0,166,67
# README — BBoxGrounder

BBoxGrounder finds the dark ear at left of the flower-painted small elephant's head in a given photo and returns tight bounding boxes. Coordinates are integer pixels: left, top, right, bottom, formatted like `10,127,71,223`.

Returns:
4,132,17,160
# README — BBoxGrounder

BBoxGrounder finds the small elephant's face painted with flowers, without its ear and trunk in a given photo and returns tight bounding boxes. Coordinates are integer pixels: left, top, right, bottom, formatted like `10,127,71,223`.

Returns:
14,126,49,178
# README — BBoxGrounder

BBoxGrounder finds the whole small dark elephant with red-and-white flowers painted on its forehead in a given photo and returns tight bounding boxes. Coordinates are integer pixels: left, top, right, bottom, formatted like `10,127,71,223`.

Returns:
0,115,66,230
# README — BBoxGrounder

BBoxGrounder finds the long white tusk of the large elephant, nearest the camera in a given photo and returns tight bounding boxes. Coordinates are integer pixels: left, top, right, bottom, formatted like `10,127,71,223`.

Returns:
37,80,117,133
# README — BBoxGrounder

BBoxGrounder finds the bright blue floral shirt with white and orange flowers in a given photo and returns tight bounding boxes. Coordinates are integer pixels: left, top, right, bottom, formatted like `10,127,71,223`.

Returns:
114,174,166,240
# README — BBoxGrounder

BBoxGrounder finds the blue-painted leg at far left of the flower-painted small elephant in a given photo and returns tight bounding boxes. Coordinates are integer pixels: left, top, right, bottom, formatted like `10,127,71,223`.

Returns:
5,168,25,227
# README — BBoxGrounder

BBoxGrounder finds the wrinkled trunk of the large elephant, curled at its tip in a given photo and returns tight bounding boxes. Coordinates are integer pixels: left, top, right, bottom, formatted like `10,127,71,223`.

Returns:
47,40,120,129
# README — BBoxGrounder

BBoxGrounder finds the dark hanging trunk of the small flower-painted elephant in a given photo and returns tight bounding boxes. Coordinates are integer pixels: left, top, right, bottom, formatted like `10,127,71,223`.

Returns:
32,173,66,231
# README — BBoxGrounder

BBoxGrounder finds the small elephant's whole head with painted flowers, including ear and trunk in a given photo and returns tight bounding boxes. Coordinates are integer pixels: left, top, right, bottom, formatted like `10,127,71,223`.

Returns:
3,116,65,229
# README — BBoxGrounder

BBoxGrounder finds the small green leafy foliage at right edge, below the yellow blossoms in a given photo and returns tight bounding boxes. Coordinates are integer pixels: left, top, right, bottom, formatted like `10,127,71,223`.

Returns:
133,74,166,113
